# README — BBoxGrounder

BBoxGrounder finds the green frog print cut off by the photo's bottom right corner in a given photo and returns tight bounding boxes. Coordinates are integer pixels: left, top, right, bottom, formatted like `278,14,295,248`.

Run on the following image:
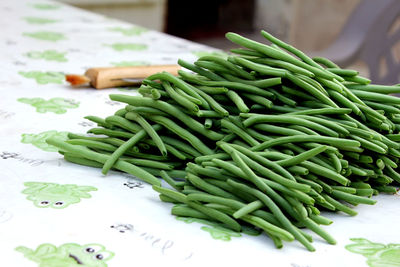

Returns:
346,238,400,267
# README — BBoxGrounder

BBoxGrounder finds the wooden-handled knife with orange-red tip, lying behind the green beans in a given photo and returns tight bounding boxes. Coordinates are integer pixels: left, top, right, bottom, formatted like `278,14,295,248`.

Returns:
65,65,181,89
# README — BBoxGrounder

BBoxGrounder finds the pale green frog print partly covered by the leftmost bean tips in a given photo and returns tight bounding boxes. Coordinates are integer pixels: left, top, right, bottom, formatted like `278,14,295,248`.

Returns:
21,130,68,152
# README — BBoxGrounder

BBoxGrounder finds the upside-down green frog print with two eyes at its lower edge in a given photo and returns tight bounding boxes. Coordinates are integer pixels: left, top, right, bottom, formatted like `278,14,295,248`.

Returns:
22,182,97,209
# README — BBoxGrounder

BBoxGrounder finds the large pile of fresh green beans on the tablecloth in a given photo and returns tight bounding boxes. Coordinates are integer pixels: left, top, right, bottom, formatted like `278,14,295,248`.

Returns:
47,31,400,251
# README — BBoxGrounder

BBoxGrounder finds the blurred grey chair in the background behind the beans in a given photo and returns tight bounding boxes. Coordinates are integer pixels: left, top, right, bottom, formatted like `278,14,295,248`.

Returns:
313,0,400,84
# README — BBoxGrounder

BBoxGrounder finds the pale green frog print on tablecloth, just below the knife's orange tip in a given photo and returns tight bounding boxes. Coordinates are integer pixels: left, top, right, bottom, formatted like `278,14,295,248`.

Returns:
18,97,79,114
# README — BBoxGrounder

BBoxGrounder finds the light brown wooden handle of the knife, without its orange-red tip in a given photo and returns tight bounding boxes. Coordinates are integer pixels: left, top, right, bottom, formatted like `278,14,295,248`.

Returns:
85,65,180,89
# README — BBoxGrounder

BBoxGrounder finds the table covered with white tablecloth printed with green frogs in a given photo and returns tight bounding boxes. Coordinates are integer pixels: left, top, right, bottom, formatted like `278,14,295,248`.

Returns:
0,0,400,267
